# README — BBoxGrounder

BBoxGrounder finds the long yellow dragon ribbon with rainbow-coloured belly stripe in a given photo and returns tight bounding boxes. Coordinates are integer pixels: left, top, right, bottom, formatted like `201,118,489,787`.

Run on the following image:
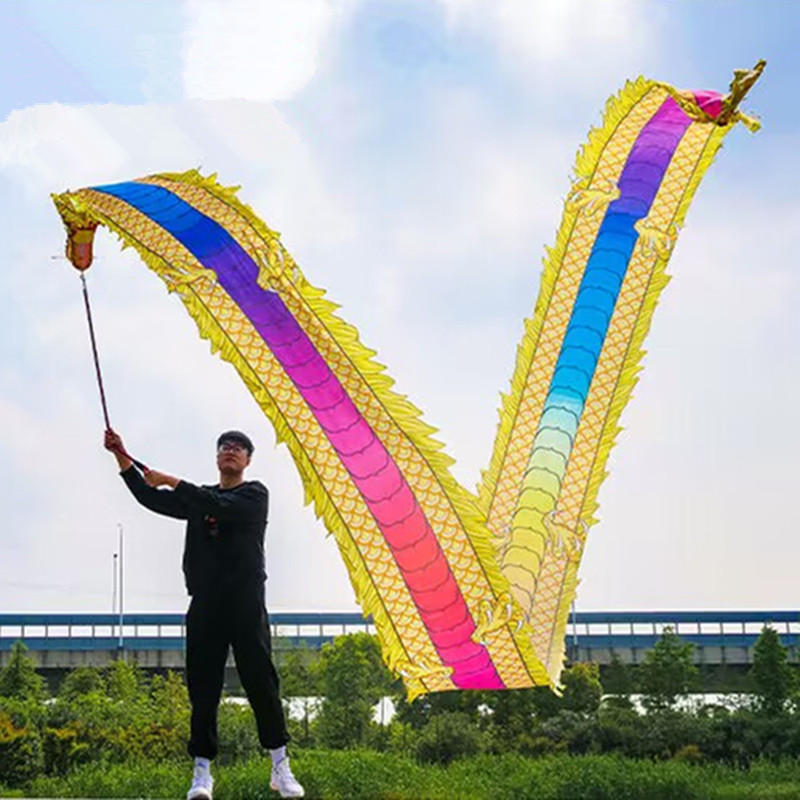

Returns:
54,63,763,697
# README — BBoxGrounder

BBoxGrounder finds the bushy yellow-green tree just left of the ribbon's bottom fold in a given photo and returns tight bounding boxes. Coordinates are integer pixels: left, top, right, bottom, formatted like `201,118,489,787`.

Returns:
316,633,391,748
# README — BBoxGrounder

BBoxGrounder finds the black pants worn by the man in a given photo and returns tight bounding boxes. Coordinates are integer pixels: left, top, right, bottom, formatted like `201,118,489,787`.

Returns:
186,584,289,759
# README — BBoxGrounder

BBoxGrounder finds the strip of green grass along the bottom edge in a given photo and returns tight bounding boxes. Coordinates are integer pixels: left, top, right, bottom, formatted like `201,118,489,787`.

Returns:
7,751,800,800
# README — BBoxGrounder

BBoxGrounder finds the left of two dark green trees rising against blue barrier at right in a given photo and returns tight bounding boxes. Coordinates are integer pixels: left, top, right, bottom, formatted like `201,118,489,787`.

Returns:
639,626,698,711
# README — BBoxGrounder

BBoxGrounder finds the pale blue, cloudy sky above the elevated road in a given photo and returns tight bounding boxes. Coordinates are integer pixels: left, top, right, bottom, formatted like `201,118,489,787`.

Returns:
0,0,800,613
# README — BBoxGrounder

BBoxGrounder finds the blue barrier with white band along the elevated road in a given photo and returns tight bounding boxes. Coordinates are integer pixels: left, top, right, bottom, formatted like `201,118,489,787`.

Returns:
0,611,800,663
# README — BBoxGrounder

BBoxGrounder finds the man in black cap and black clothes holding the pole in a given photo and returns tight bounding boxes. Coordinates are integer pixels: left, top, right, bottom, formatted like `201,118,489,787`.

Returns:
105,430,304,800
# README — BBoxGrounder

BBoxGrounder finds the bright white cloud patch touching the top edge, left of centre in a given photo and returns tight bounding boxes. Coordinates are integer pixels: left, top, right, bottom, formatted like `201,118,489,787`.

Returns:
183,0,348,100
